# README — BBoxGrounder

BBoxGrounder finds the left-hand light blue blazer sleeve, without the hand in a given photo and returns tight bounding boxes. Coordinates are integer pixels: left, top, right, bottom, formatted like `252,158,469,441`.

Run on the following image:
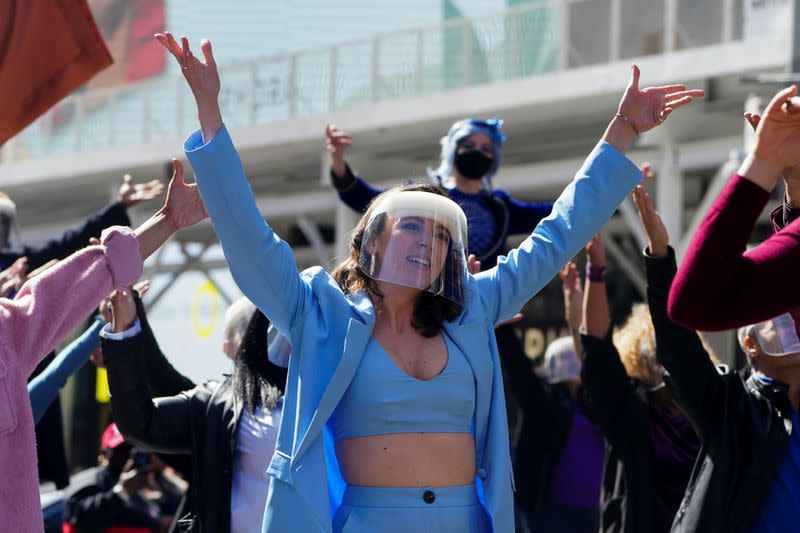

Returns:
184,125,313,335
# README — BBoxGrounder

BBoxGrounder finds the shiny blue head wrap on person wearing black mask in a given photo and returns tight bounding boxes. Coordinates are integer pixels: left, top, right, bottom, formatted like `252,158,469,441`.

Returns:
428,117,506,189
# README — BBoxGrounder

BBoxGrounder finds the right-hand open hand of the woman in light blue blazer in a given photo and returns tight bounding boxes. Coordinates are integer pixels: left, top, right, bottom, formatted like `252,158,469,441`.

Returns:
617,65,705,134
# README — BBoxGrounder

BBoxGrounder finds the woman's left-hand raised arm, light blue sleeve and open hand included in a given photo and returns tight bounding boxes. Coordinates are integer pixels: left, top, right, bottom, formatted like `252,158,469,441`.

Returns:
156,33,311,334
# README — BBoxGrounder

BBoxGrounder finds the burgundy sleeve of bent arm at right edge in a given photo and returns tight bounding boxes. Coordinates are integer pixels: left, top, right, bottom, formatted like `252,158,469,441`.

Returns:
669,174,800,331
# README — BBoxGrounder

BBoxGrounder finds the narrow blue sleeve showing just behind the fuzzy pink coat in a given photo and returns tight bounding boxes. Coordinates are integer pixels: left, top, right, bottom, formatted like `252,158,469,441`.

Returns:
28,318,104,424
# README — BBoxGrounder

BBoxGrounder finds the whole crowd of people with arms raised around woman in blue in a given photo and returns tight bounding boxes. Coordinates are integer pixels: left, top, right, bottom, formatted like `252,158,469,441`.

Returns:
0,33,800,533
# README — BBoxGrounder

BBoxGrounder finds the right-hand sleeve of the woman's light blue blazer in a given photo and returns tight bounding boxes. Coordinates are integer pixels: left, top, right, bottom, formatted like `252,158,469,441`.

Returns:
475,141,641,324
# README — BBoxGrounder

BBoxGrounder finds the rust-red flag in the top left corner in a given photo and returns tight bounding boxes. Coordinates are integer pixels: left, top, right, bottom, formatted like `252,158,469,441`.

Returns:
0,0,112,144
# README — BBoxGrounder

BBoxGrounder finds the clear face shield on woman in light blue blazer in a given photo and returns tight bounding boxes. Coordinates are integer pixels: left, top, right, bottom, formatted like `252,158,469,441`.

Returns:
359,191,467,306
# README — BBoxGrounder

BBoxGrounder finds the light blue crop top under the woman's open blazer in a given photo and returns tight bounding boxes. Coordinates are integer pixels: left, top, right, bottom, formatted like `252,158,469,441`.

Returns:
328,334,475,441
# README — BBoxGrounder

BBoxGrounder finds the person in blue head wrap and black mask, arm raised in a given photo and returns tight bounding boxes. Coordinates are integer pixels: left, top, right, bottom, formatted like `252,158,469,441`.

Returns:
325,117,553,269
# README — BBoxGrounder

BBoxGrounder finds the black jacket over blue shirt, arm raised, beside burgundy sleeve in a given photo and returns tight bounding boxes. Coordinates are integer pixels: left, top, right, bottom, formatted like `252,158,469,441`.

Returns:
645,247,792,533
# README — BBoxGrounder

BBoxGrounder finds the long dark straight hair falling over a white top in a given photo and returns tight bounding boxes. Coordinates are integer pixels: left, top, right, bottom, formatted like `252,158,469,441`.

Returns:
232,309,287,414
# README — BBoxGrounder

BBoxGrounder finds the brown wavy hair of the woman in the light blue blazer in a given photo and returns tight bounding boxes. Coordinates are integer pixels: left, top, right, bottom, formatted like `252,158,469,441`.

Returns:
331,183,462,337
